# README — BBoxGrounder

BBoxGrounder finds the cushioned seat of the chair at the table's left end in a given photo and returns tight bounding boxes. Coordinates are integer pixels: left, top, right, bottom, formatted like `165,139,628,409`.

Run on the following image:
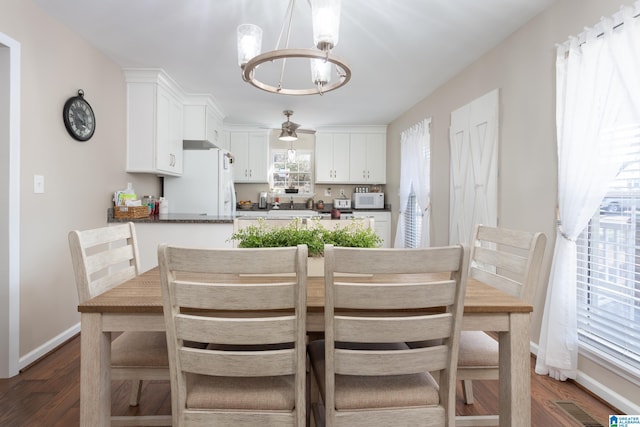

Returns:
111,332,169,369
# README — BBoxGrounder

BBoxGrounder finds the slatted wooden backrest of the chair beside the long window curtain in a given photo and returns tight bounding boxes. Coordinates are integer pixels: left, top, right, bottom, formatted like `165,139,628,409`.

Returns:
469,225,547,304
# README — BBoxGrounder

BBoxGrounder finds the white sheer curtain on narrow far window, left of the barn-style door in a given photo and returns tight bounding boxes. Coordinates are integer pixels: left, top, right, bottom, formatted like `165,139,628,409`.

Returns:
393,118,431,248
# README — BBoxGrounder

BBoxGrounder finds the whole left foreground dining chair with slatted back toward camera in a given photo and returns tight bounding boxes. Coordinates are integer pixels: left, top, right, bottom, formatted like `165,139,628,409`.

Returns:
158,245,307,427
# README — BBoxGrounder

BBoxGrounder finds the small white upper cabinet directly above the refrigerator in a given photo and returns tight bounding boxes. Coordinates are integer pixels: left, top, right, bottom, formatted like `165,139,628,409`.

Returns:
183,95,227,148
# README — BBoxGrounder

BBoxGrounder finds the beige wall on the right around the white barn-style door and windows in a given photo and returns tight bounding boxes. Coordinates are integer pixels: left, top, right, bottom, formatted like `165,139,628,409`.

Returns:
387,0,640,412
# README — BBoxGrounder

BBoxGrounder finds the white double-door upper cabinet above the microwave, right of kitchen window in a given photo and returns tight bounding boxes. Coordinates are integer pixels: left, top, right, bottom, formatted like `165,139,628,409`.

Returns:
315,126,387,184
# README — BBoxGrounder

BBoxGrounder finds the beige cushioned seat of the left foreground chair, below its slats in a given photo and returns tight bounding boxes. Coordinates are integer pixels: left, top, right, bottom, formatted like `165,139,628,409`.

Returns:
186,374,295,411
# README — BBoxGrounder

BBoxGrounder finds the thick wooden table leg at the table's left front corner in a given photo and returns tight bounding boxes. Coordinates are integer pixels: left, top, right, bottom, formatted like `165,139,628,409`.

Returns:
80,313,111,427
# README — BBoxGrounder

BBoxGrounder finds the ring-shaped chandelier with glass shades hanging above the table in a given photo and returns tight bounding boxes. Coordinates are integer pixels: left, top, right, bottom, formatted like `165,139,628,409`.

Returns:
237,0,351,95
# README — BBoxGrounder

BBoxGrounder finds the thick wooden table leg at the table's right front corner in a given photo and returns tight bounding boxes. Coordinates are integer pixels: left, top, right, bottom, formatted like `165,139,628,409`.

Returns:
499,313,531,427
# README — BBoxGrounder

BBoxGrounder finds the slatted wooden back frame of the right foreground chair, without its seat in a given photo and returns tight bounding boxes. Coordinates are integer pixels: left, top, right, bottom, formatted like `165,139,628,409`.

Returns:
325,245,469,425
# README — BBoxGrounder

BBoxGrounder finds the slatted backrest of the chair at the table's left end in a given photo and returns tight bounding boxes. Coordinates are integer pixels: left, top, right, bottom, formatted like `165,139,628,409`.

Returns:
69,222,140,303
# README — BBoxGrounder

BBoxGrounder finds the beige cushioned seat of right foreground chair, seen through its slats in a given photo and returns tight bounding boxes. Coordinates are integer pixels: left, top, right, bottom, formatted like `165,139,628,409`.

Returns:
309,340,439,410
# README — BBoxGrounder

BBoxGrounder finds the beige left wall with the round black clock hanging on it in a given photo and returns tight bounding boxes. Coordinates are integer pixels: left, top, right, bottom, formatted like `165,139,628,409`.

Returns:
0,0,159,359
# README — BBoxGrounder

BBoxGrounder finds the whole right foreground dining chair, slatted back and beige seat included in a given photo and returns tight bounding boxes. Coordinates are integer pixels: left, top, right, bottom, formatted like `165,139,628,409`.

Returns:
309,245,469,427
